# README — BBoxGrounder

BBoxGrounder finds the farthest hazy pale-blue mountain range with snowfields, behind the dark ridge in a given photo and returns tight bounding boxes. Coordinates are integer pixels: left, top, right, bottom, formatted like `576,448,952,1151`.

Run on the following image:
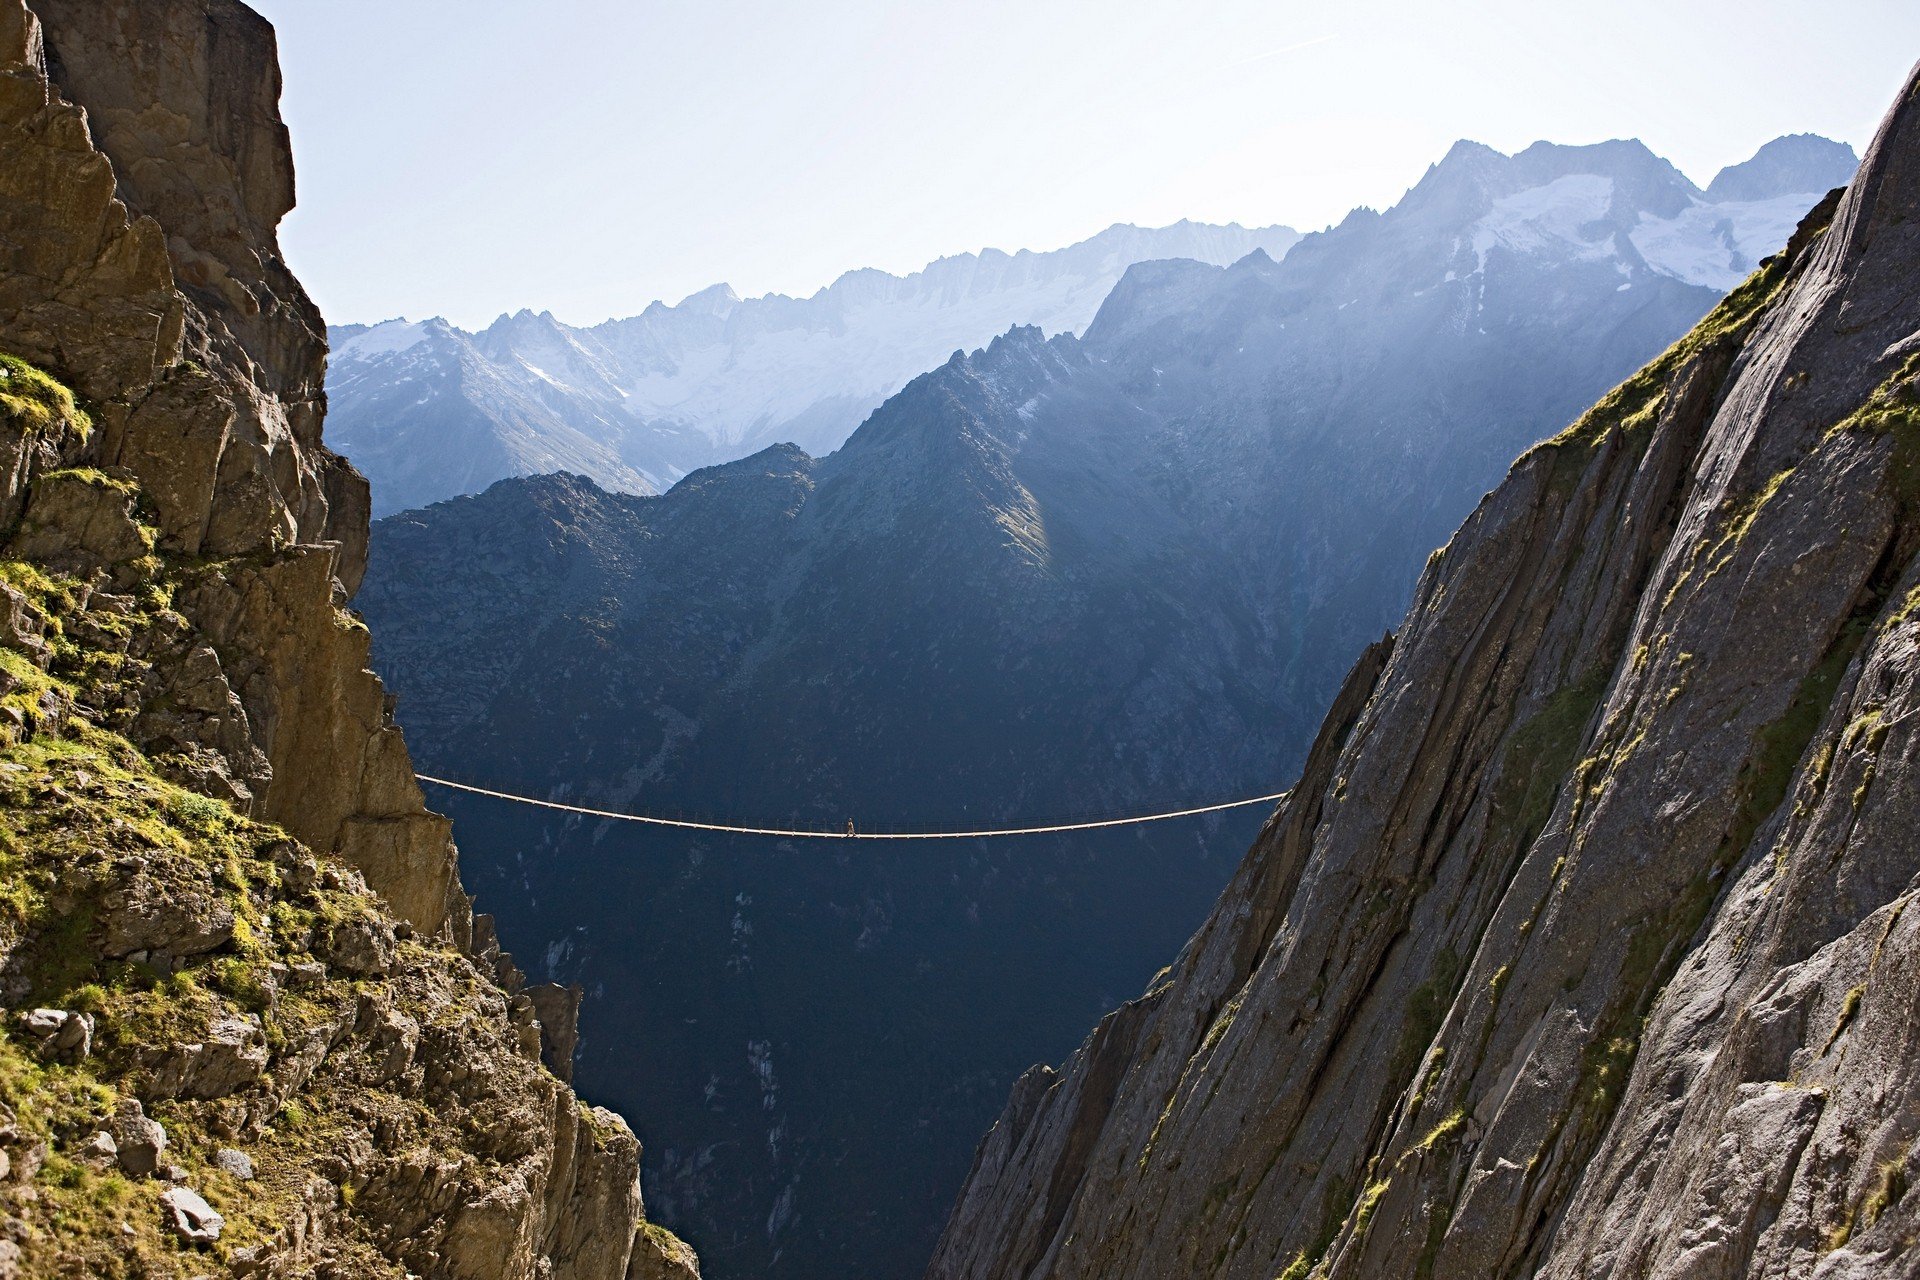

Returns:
326,223,1300,514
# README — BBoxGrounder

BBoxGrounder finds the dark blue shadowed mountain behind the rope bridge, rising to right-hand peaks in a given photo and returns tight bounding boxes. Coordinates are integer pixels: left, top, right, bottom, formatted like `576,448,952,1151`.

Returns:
361,142,1847,1280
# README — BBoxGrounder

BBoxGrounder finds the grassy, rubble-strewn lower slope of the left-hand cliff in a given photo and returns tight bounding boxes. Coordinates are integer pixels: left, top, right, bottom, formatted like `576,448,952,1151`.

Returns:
0,487,607,1280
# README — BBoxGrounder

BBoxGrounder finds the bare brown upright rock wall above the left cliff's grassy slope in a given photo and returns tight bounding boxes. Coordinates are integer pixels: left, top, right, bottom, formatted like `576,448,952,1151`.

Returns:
6,2,439,931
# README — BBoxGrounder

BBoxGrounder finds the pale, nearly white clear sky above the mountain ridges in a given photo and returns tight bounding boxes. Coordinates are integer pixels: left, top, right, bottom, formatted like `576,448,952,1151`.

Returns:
252,0,1920,324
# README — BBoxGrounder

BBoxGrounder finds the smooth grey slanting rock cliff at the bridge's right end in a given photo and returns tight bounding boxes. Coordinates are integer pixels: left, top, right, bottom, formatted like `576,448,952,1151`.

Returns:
929,67,1920,1280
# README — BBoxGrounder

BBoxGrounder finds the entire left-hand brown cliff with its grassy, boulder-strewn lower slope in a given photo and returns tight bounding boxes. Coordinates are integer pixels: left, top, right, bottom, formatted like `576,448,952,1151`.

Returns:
0,0,693,1280
